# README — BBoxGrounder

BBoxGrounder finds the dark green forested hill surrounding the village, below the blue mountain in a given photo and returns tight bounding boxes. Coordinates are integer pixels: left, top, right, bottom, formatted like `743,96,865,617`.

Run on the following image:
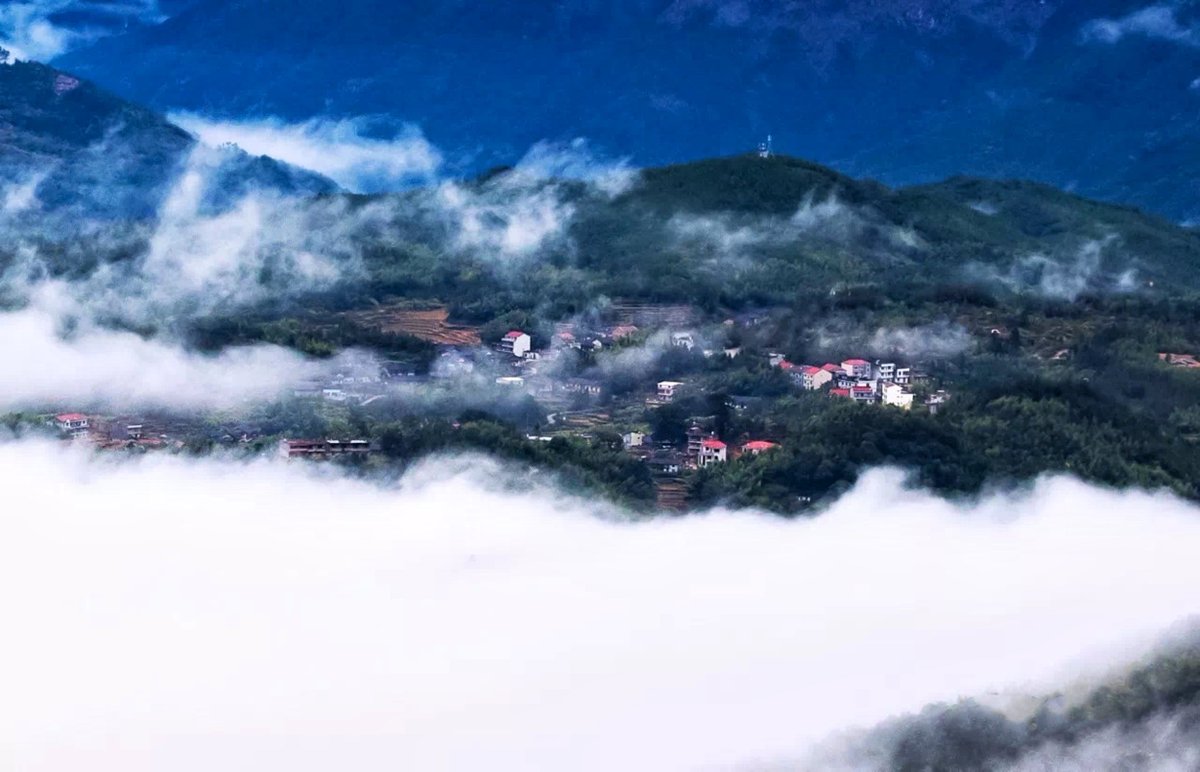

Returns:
21,149,1200,514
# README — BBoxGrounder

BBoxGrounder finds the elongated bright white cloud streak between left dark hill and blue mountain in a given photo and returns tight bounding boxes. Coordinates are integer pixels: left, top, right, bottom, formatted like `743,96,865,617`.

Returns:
170,113,442,193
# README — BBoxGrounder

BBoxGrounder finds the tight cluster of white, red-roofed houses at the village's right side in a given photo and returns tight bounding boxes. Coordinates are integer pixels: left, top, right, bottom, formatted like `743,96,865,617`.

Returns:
770,354,925,411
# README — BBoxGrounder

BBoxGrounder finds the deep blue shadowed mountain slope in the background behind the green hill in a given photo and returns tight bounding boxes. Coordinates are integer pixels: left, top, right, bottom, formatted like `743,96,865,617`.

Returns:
51,0,1200,220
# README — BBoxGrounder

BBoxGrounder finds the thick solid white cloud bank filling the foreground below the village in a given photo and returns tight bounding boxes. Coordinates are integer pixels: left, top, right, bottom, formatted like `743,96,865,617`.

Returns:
0,442,1200,772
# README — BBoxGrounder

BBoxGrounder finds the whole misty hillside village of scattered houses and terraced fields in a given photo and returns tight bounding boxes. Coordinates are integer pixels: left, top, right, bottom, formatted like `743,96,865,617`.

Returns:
30,296,1200,509
